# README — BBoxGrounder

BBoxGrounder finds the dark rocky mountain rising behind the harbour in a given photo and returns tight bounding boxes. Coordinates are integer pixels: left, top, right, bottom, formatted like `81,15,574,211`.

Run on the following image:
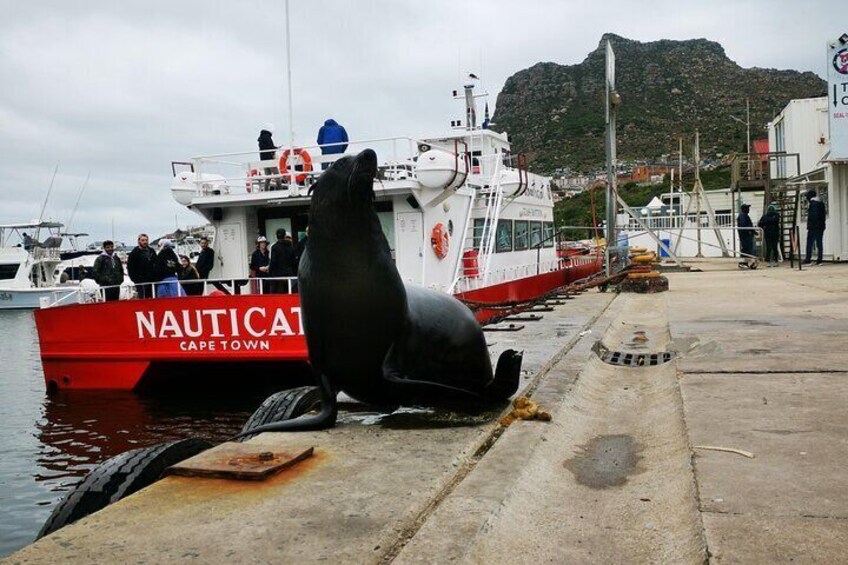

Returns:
492,34,827,173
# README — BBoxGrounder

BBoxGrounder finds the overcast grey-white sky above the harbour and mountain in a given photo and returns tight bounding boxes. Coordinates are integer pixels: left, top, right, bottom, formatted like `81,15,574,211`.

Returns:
0,0,848,243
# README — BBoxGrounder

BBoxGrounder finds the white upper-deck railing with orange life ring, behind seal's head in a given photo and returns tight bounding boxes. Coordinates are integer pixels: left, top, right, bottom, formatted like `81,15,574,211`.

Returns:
172,137,423,197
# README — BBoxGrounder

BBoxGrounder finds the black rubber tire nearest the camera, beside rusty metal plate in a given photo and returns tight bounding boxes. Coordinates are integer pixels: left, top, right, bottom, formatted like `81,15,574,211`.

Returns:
36,438,212,539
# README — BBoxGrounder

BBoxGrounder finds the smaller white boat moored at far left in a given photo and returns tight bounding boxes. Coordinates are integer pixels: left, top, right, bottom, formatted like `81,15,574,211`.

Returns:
0,222,77,310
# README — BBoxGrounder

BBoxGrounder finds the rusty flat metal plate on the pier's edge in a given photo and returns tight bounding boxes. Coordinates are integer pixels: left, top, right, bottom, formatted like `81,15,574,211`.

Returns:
165,442,315,481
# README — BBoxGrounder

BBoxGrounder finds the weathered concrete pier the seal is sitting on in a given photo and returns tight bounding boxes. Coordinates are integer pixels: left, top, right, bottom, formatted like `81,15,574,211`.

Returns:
4,261,848,563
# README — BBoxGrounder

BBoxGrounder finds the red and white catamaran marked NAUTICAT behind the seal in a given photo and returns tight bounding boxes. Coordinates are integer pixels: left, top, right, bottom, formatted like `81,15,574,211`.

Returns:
35,85,603,389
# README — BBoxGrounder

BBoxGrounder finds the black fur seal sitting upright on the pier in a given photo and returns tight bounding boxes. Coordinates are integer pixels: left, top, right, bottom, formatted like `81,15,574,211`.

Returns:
238,149,521,433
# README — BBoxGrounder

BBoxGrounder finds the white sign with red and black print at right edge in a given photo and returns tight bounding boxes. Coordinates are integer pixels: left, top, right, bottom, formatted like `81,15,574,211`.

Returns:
827,34,848,160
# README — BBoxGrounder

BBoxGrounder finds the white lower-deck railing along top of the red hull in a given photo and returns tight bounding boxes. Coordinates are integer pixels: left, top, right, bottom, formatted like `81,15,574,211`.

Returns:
41,277,304,308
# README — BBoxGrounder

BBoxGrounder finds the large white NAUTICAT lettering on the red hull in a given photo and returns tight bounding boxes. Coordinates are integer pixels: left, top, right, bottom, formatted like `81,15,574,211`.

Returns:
135,306,303,340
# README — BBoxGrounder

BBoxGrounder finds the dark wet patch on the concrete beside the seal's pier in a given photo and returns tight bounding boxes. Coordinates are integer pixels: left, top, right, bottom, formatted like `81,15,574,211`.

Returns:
563,435,642,489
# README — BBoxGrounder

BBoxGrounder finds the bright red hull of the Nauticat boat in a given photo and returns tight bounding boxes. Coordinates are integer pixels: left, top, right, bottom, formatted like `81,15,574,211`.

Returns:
35,257,601,390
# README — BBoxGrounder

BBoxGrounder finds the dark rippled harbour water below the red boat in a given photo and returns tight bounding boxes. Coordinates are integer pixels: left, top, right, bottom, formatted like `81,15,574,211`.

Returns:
0,311,267,557
